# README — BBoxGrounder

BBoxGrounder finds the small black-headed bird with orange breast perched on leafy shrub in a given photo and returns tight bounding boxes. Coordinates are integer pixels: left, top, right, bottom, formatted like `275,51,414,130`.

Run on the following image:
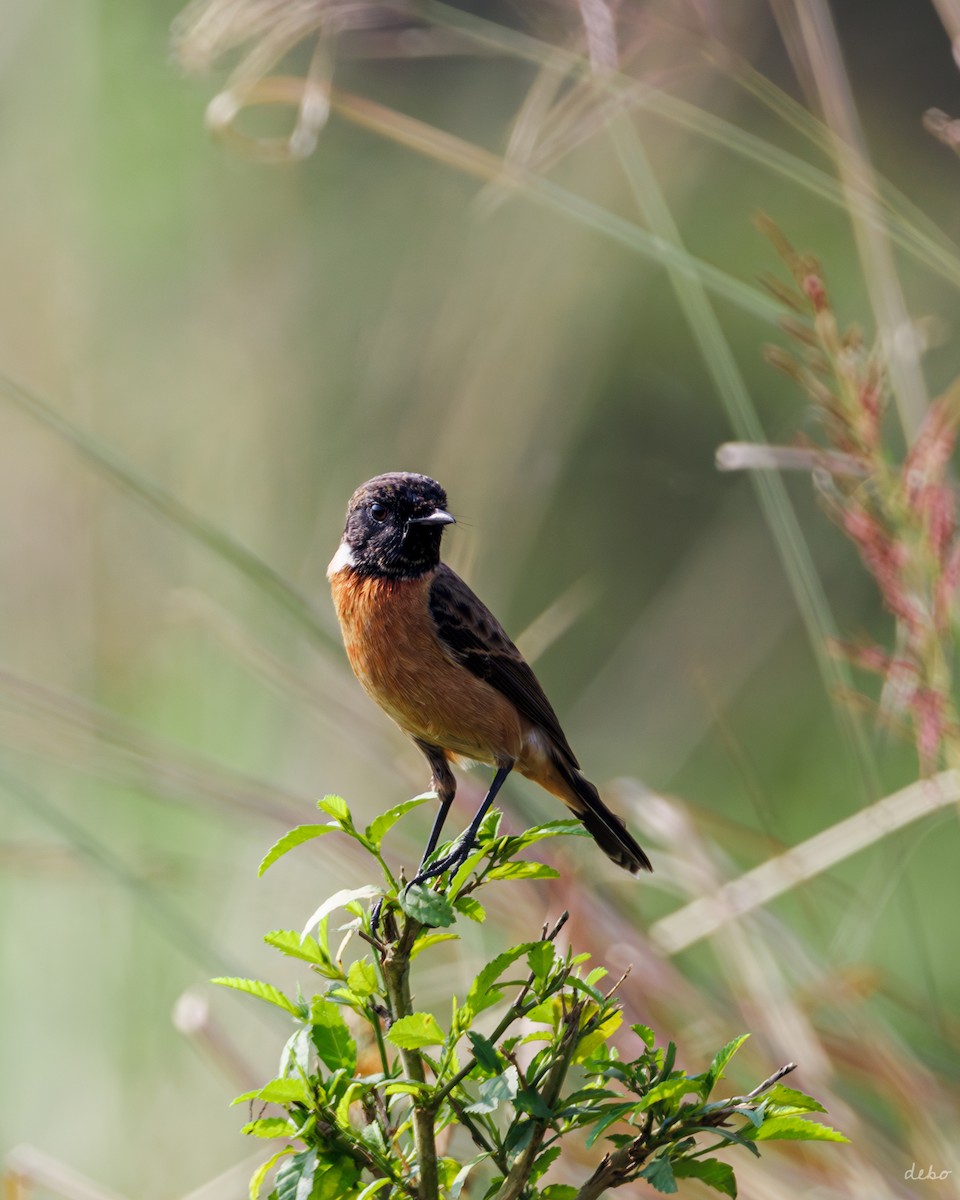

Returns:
326,472,653,883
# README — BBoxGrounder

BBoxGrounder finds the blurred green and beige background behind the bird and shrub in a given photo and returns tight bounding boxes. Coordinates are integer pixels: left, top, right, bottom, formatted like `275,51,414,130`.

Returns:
0,0,960,1200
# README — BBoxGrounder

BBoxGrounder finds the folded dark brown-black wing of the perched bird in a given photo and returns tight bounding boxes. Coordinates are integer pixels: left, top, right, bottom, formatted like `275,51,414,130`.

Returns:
430,564,580,767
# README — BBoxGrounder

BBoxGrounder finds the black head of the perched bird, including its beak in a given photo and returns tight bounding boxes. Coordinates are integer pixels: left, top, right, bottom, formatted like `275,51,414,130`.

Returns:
330,472,454,578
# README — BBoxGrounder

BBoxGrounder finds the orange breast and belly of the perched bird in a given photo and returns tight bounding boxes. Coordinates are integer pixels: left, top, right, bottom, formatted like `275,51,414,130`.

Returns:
330,568,522,763
